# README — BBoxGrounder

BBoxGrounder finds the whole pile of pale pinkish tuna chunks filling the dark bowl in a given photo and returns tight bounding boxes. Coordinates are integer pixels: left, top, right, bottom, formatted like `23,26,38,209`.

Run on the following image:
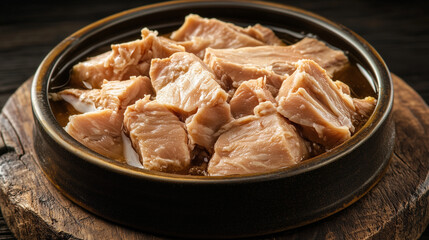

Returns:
50,14,377,176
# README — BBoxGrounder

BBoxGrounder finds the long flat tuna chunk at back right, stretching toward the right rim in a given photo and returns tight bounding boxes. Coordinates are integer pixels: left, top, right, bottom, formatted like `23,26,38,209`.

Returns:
204,38,348,96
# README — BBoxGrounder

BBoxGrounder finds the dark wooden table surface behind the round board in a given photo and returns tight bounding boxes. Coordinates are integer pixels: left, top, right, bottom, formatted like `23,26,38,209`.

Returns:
0,0,429,240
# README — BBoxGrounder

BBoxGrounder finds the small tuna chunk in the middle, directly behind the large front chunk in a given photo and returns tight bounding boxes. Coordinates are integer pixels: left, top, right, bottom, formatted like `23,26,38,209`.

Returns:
229,78,276,118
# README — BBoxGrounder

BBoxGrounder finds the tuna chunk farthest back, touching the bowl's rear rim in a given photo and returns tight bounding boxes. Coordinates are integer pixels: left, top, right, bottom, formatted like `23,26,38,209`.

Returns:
171,14,281,58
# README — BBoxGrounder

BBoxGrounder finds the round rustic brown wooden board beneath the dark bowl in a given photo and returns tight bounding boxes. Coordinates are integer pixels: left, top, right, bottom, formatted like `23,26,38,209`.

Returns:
0,75,429,240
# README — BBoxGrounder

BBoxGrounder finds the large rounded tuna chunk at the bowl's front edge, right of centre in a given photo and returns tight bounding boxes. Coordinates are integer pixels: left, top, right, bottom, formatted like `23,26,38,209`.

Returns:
208,102,308,176
